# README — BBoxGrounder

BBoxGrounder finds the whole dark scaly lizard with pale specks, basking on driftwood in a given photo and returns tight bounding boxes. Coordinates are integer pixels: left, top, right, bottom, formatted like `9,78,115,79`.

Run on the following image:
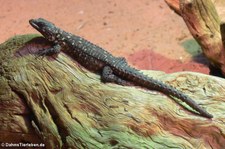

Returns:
29,18,213,118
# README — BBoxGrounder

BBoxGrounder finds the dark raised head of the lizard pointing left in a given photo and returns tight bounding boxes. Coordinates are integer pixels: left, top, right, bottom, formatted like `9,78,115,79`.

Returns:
29,18,59,41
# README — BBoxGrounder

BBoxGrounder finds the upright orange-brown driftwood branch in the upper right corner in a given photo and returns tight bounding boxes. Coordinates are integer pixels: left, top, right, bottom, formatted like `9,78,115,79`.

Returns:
165,0,225,77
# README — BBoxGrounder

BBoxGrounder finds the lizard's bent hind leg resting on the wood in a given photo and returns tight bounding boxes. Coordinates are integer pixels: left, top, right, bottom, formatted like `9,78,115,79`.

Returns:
101,66,128,85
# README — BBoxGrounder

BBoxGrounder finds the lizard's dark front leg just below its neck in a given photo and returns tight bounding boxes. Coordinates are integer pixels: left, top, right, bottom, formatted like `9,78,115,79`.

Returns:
36,44,62,57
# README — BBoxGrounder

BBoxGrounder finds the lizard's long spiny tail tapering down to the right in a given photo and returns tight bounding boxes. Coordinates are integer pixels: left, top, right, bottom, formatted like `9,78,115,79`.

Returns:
130,72,213,118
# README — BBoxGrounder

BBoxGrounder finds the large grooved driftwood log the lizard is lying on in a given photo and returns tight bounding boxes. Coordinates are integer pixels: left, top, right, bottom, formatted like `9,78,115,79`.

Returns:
0,35,225,149
